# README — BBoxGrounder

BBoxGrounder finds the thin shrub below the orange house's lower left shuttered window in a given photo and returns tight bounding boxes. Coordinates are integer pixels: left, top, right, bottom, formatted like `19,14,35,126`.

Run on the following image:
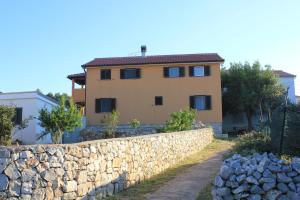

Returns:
101,111,120,138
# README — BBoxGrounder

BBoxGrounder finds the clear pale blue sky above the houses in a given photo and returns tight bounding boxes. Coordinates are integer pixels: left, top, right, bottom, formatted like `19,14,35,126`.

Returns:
0,0,300,95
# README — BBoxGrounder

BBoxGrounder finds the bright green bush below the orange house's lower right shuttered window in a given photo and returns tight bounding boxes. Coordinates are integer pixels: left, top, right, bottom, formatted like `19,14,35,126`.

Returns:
164,109,196,132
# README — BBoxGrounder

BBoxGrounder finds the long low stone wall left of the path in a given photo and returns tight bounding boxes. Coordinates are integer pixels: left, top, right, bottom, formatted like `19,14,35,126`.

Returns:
0,128,213,199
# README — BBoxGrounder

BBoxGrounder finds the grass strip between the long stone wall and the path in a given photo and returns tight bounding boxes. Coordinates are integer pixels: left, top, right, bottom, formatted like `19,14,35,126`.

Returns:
106,139,234,200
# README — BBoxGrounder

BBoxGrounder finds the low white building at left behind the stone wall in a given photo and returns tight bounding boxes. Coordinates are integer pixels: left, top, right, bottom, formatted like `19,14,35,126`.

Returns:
0,91,58,144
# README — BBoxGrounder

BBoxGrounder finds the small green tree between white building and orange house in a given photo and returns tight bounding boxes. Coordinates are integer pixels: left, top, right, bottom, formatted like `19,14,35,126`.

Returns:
38,96,81,144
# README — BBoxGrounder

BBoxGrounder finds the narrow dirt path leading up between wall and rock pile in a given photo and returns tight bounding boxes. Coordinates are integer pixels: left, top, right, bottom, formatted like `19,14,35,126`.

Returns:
145,150,228,200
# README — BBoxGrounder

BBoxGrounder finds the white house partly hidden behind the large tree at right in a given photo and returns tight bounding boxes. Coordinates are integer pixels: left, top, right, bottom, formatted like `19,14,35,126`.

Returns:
273,70,297,104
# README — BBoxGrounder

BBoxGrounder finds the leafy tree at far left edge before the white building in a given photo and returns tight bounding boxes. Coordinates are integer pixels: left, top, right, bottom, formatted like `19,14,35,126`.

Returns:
0,105,31,145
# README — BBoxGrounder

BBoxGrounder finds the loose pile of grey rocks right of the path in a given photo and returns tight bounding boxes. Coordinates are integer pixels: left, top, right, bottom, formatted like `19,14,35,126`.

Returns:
212,153,300,200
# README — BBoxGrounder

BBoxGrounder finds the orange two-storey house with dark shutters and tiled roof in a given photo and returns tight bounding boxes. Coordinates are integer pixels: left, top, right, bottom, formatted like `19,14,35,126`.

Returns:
68,46,224,133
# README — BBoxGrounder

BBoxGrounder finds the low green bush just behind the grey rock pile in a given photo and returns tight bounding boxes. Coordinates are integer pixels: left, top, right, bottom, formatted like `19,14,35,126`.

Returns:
234,131,272,155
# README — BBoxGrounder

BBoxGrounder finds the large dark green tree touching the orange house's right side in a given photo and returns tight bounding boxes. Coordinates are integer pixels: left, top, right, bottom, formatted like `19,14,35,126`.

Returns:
221,61,284,131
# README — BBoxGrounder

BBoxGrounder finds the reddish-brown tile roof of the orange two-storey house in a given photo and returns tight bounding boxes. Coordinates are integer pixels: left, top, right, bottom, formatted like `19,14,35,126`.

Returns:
82,53,224,68
